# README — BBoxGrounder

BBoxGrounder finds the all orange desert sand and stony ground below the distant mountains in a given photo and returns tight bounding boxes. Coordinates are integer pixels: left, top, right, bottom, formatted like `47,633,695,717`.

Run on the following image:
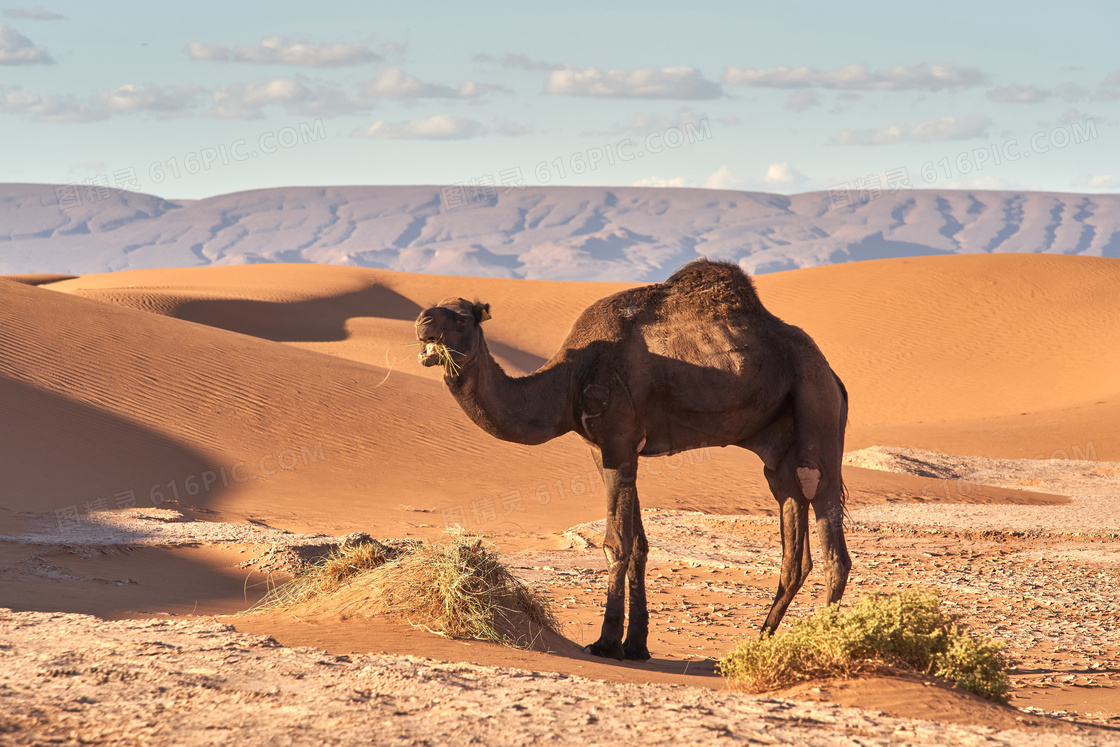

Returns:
0,254,1120,744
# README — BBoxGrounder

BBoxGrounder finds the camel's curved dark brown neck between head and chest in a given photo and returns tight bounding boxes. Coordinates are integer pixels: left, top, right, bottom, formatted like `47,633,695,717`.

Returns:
444,338,572,445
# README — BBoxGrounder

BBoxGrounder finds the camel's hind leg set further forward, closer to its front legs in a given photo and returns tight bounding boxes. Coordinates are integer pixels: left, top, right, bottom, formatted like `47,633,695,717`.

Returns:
763,451,813,633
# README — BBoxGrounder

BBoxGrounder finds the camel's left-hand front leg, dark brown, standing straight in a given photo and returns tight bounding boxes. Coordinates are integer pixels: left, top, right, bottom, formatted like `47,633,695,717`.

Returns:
584,442,648,659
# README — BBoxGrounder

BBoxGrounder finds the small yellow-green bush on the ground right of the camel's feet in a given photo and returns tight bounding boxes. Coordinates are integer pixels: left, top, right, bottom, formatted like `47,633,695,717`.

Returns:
719,590,1008,702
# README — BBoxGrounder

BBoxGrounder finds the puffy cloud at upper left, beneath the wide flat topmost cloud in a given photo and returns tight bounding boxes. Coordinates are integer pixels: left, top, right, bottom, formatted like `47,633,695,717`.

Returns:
204,78,370,120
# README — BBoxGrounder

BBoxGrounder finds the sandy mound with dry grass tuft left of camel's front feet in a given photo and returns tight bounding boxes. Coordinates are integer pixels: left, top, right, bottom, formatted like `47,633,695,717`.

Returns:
253,533,558,647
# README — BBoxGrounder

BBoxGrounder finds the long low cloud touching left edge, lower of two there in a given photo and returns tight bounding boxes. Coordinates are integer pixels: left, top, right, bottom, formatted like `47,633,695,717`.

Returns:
0,85,200,124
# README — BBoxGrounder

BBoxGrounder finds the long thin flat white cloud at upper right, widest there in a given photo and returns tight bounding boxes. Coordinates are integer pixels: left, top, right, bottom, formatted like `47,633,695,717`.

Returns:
724,63,988,91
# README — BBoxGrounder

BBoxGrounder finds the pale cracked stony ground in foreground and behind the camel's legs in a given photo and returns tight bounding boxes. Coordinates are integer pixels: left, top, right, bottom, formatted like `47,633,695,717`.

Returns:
0,450,1120,745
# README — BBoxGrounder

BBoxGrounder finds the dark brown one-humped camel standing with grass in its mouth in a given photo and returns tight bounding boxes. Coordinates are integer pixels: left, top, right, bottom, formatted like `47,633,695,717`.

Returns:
416,259,851,661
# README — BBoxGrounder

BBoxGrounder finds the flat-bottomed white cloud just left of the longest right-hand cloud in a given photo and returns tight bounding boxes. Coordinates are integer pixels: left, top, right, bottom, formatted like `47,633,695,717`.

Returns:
544,67,724,100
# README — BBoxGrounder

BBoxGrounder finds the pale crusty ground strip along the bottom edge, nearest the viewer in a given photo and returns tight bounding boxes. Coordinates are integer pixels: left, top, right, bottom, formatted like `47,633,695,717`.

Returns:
0,613,1120,746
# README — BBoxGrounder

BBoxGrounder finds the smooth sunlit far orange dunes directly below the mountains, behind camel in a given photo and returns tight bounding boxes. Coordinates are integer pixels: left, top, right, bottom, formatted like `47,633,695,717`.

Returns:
41,255,1120,459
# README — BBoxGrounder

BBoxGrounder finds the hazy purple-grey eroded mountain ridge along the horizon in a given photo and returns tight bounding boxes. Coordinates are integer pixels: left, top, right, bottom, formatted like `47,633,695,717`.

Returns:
0,184,1120,282
